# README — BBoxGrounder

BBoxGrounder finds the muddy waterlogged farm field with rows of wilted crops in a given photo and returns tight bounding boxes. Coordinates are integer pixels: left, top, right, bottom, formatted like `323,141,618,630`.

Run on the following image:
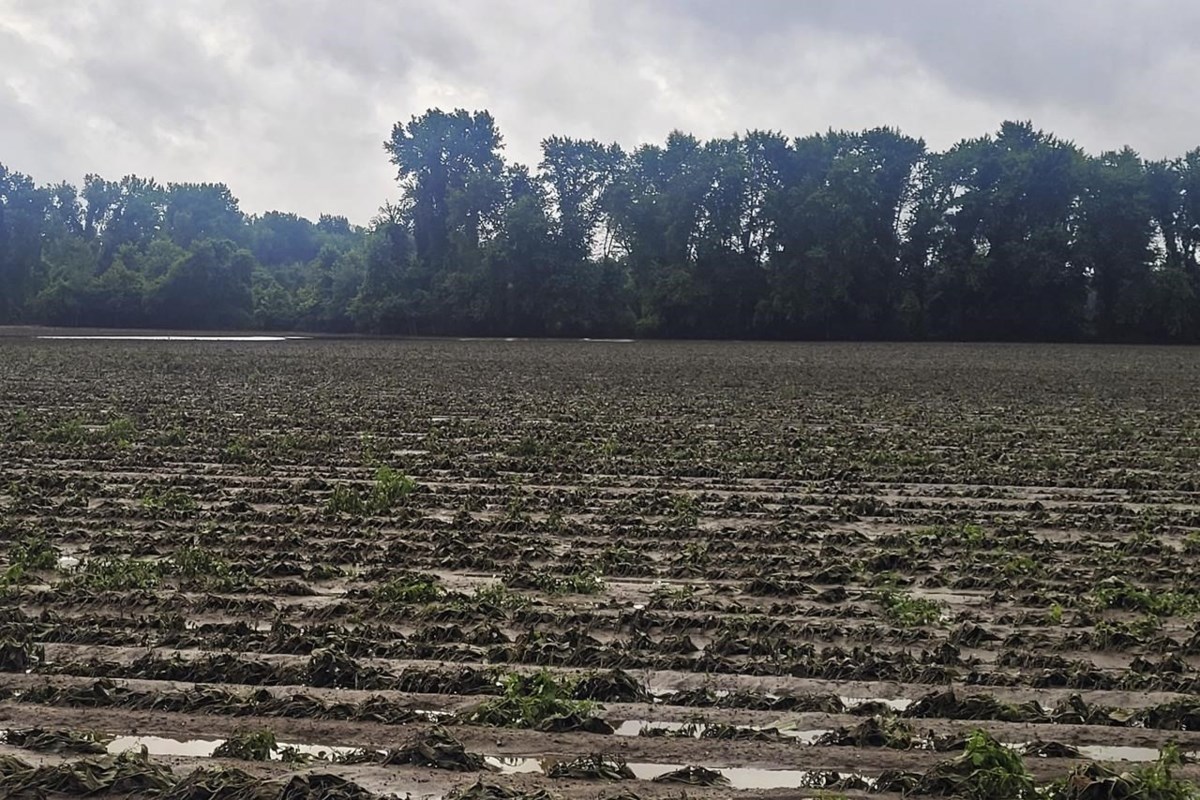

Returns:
0,335,1200,800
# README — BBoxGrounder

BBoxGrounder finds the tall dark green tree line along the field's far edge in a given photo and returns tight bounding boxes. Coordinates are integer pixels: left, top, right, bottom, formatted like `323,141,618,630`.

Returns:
0,109,1200,342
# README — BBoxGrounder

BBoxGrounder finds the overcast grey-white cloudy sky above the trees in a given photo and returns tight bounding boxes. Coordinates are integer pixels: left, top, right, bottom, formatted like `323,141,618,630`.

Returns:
0,0,1200,223
